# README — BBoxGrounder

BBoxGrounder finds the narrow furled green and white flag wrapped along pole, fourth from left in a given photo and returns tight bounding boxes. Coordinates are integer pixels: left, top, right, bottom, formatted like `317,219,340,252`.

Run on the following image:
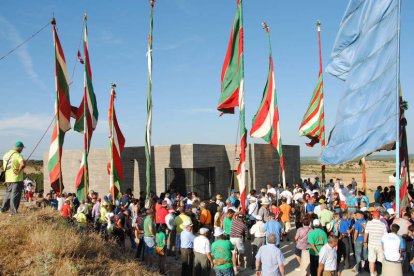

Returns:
145,0,155,203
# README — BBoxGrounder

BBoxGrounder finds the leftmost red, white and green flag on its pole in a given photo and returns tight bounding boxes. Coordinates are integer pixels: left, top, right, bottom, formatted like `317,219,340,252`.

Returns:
48,18,71,192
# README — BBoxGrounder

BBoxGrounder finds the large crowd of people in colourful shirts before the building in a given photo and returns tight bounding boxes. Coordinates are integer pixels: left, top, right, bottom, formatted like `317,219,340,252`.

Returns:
23,178,414,276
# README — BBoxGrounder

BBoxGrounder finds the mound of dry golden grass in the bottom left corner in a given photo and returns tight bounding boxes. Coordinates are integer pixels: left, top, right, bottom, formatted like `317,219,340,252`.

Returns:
0,209,158,276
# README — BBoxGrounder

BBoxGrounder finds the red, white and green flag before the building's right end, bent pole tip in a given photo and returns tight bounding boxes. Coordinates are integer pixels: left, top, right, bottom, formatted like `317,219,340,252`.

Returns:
250,22,286,187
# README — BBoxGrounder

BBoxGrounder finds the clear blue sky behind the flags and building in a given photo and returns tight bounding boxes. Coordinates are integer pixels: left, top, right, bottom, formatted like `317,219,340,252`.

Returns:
0,0,414,159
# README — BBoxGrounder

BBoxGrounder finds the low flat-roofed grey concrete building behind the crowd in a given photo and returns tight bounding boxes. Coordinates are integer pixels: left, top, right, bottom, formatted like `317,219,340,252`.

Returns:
44,144,300,198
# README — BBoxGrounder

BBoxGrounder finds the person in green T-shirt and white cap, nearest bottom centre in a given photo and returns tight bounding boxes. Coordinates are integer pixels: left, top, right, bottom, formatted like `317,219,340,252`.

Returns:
211,228,237,276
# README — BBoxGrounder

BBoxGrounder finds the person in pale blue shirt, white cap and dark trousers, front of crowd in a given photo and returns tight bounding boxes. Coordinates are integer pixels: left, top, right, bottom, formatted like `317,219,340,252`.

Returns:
180,221,194,276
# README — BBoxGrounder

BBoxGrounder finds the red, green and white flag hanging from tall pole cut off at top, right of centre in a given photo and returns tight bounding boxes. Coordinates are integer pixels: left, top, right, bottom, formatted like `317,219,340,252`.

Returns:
217,0,247,213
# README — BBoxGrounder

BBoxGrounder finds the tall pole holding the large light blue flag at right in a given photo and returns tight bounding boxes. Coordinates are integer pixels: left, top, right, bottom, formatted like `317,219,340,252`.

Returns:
395,0,401,218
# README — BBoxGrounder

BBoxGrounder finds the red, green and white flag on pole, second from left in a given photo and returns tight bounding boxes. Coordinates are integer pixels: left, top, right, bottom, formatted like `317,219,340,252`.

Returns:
74,15,98,200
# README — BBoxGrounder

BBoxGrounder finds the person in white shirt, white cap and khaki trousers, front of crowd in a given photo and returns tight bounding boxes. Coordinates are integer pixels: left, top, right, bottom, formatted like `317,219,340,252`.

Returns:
194,227,213,276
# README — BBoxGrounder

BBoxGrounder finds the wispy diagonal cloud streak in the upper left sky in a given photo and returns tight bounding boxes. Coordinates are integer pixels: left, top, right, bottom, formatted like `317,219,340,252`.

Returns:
0,16,49,92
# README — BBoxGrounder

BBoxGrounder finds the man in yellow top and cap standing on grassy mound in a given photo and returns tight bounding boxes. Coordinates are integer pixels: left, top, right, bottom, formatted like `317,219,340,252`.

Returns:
0,142,26,215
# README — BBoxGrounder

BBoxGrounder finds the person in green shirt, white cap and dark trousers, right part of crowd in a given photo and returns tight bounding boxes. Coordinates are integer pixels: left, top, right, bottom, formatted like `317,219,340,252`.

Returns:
308,219,328,276
